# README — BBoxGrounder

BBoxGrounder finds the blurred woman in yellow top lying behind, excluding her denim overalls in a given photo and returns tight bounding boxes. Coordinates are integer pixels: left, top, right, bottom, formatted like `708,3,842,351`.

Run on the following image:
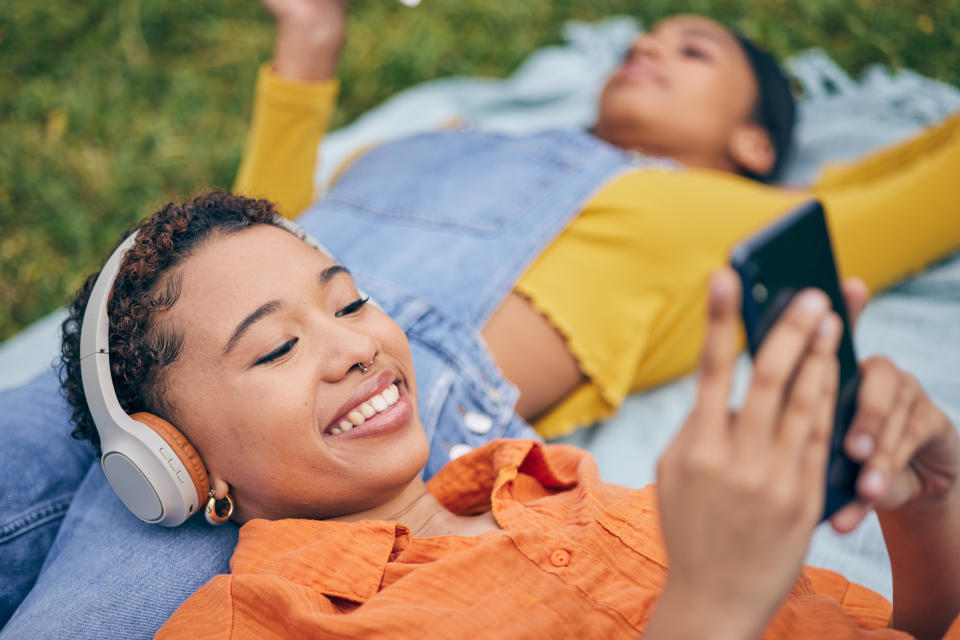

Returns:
236,0,960,437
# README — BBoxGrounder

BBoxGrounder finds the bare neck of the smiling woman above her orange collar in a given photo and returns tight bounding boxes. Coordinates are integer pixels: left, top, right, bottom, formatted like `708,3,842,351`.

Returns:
333,476,497,538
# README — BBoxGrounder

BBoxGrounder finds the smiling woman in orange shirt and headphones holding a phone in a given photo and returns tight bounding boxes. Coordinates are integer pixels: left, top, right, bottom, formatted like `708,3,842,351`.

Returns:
65,194,960,638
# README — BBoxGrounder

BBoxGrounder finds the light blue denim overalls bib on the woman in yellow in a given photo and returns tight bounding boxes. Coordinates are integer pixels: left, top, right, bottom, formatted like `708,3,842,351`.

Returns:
298,129,640,330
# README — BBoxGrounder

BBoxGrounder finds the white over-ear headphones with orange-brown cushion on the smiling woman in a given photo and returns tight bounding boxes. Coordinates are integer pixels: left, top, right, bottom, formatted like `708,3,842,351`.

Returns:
80,216,342,527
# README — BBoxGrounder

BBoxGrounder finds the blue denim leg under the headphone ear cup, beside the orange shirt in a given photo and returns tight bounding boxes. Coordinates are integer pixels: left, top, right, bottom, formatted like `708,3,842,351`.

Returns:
0,465,239,640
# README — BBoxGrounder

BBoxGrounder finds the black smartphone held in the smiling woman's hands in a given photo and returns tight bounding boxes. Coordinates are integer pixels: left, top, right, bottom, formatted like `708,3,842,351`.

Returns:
730,200,860,520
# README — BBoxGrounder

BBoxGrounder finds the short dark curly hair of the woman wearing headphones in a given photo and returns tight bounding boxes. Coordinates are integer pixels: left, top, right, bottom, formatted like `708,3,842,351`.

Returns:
60,192,277,453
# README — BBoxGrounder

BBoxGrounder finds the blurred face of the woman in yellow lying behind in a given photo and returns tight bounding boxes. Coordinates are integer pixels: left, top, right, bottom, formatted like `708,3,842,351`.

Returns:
595,15,757,171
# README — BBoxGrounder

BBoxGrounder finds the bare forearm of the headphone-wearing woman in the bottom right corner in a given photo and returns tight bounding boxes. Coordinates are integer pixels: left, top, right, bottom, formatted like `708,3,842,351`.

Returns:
879,485,960,640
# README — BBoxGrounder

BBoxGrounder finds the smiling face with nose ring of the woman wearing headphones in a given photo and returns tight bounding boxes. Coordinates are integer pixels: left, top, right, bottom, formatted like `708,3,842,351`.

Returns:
160,225,428,522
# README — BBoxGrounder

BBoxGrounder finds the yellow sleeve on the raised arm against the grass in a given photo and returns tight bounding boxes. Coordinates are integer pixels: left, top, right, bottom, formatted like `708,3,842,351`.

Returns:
234,64,339,218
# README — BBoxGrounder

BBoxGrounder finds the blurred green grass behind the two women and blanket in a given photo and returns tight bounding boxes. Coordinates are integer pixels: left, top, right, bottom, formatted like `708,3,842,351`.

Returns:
0,0,960,339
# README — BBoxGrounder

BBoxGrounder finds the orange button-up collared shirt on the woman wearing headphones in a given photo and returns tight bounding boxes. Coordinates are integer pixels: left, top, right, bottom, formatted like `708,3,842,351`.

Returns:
157,440,960,639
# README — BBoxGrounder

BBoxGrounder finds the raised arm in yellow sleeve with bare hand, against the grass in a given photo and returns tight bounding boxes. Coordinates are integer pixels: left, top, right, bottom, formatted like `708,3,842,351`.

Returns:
234,0,346,218
